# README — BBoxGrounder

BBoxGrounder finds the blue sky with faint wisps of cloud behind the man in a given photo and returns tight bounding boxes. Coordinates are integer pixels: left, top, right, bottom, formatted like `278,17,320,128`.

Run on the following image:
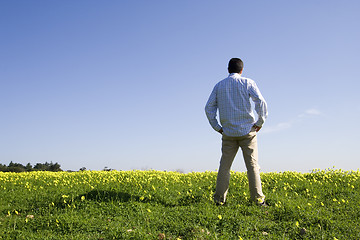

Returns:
0,0,360,172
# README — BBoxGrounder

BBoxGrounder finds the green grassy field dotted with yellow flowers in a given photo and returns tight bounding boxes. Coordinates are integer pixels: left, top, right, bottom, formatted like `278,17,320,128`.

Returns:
0,169,360,240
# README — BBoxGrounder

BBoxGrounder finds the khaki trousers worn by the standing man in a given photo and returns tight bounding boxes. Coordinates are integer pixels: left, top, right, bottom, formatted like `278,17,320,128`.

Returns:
214,128,265,203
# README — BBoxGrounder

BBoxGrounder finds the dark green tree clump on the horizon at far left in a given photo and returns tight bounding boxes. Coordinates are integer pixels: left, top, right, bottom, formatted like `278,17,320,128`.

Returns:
0,161,62,172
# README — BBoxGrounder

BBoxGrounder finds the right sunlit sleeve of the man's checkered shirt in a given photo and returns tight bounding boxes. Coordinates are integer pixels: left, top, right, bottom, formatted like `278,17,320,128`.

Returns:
249,82,268,127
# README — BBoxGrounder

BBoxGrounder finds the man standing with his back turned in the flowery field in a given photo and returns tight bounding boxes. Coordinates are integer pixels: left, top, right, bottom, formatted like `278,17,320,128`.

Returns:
205,58,267,206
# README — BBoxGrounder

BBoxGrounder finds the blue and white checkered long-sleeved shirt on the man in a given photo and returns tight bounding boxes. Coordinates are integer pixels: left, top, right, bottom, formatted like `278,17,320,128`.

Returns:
205,73,268,137
